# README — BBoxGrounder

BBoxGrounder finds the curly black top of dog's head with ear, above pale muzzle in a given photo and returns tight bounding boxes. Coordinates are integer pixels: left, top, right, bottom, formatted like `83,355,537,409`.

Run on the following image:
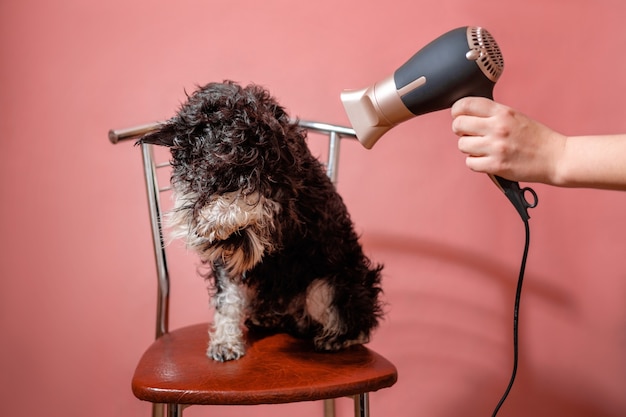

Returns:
140,81,306,205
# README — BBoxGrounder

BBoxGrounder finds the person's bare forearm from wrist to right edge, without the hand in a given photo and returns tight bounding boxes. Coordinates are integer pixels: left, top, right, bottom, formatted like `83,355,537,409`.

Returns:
551,134,626,190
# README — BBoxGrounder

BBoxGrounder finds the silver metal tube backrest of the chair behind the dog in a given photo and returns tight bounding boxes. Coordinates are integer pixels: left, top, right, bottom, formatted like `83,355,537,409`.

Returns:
109,120,356,338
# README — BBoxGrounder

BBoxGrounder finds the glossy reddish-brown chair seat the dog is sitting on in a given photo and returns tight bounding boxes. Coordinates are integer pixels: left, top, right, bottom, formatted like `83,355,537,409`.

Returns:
132,323,397,405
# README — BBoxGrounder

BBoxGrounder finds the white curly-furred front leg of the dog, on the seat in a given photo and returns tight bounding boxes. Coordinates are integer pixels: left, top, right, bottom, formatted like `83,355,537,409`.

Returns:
207,271,246,362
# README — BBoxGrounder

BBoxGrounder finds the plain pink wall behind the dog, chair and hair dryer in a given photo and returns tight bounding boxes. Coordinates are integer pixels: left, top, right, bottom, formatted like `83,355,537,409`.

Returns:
0,0,626,417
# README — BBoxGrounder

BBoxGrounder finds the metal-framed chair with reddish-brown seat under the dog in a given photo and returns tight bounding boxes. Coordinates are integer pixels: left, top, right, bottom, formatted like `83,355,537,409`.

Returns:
109,121,397,417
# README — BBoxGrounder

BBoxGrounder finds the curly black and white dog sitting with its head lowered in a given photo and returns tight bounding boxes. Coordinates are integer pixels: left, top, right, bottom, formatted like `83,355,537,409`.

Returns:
139,80,383,361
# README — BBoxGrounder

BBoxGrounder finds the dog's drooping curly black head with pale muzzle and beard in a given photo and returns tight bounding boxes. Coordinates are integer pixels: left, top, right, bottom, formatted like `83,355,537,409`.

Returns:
140,81,310,269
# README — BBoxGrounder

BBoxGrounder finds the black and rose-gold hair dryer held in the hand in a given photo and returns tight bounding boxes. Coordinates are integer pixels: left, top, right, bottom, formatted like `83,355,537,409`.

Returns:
341,26,537,221
